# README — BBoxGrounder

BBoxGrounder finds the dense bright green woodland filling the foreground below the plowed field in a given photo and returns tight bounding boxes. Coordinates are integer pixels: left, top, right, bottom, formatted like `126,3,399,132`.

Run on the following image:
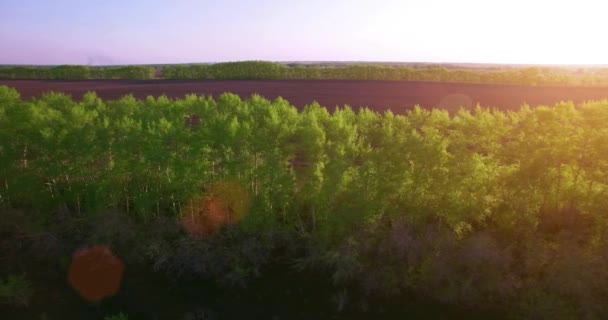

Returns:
0,87,608,319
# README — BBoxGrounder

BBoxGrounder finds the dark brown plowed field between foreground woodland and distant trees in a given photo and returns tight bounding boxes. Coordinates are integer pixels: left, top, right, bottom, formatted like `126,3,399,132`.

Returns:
0,80,608,113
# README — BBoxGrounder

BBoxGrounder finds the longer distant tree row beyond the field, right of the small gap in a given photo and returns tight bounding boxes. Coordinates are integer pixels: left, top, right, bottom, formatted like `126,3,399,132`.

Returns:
162,61,608,86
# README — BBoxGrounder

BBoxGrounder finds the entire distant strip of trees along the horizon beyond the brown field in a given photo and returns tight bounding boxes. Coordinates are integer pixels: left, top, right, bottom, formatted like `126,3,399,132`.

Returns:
0,61,608,86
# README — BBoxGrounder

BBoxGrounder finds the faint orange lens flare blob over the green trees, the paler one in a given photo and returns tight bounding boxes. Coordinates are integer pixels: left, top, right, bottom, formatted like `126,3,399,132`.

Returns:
181,182,250,237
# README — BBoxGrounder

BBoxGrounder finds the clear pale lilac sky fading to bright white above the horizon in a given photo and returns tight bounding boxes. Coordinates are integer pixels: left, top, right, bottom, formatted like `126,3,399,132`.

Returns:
0,0,608,65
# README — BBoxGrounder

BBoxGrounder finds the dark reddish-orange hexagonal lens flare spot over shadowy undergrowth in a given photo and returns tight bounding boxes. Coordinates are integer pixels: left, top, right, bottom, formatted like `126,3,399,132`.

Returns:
68,245,125,302
